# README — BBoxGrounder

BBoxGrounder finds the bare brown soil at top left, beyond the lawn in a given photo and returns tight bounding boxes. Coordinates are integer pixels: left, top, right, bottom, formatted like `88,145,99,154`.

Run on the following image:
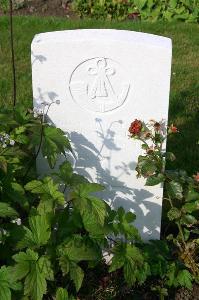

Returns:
0,0,78,18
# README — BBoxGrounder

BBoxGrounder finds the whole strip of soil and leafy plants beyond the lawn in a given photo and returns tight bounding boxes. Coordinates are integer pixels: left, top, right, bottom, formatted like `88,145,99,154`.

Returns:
0,0,199,23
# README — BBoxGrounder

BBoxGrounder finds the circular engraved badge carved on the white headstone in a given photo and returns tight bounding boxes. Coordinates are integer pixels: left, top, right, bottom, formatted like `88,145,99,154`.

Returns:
69,57,130,113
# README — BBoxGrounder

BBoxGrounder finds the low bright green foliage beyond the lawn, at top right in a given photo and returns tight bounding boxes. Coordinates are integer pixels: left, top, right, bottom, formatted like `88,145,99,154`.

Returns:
73,0,199,22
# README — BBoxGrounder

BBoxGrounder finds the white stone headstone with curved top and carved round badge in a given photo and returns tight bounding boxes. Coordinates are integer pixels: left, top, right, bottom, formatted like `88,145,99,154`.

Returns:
32,30,172,240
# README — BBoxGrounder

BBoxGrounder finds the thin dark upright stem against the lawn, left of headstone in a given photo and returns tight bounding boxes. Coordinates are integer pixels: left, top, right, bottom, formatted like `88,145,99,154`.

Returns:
10,0,17,107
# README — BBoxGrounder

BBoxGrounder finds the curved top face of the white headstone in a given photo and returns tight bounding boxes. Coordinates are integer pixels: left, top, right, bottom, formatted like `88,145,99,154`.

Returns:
32,29,171,49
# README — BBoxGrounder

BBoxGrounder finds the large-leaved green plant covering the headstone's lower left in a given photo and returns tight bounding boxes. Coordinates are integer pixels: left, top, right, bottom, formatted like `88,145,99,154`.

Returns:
0,101,148,300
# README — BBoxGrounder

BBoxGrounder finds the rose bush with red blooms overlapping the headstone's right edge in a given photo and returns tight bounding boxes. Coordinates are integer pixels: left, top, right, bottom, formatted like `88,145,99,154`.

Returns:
129,116,199,282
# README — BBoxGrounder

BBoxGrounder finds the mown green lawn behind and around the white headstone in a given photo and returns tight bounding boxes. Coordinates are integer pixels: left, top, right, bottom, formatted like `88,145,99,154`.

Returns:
0,17,199,174
